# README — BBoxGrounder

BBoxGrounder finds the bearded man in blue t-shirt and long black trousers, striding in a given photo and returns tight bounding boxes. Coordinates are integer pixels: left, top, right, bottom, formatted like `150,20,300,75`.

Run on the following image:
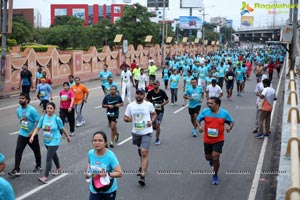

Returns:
8,92,41,176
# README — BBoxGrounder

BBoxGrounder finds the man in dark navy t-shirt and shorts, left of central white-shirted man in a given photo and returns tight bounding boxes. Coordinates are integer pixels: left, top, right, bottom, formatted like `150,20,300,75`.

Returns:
102,86,123,148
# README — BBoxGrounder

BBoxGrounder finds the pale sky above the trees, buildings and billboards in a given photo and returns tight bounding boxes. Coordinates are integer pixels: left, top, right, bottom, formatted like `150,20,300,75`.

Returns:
13,0,296,29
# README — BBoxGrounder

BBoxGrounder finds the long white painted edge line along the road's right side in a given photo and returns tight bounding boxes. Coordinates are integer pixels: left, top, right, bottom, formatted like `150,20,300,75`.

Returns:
248,60,284,200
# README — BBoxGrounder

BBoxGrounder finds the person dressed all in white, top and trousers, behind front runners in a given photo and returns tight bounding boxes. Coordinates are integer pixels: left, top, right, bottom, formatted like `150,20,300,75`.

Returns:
121,67,135,103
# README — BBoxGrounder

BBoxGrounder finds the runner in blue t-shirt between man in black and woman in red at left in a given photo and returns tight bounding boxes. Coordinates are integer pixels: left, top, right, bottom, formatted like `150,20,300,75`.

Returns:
34,77,53,112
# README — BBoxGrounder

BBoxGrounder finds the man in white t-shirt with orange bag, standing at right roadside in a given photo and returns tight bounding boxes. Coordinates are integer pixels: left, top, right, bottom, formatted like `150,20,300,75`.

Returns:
255,79,276,139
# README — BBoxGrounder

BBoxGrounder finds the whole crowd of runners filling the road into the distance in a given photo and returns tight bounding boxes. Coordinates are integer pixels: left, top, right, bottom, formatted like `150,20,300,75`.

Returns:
0,44,285,199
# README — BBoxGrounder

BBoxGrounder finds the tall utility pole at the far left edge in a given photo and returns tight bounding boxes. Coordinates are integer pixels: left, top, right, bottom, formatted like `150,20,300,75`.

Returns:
0,0,8,98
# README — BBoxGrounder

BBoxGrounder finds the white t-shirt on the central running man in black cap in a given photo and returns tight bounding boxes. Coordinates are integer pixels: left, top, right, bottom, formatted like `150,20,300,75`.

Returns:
125,101,155,135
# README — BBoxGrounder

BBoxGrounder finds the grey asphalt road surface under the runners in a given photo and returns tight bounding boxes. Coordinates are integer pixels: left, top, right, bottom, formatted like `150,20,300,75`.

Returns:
0,72,288,200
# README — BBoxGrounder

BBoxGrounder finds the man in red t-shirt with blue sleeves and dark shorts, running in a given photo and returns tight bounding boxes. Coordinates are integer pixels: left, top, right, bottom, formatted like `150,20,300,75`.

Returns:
197,97,234,185
